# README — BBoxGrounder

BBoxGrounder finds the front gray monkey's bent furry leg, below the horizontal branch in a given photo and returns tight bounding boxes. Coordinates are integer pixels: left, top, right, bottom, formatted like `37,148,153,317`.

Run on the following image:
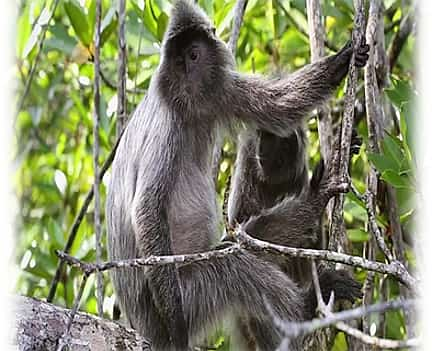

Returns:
179,252,306,350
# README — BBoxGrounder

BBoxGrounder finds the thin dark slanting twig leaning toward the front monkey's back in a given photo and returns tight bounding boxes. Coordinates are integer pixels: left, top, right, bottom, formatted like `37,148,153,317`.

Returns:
47,136,125,302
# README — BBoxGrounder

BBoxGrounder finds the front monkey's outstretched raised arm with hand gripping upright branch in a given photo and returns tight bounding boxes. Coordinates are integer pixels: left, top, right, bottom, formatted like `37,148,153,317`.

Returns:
225,42,369,136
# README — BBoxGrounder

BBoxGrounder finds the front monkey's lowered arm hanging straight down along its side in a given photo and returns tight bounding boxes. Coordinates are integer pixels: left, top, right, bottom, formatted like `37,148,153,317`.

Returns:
133,157,188,350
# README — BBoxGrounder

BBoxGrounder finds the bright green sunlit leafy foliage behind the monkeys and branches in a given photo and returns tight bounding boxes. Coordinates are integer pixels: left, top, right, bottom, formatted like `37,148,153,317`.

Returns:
14,0,416,350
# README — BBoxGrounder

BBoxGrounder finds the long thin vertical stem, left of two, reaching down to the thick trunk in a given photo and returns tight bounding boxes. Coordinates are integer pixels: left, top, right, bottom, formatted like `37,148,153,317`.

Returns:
93,0,104,317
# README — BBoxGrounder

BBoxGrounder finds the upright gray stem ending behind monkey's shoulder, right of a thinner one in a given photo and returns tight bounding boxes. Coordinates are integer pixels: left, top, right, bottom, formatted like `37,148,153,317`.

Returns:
117,0,127,136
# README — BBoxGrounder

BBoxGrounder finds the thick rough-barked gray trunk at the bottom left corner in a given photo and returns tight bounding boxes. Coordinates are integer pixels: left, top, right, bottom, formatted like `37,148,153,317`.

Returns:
13,297,151,351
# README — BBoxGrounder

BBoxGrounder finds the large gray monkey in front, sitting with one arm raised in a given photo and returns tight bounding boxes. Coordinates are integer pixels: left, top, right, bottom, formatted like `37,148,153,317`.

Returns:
106,0,368,351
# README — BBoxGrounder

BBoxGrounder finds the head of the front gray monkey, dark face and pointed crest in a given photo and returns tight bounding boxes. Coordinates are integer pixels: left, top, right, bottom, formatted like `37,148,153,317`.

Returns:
157,0,234,114
